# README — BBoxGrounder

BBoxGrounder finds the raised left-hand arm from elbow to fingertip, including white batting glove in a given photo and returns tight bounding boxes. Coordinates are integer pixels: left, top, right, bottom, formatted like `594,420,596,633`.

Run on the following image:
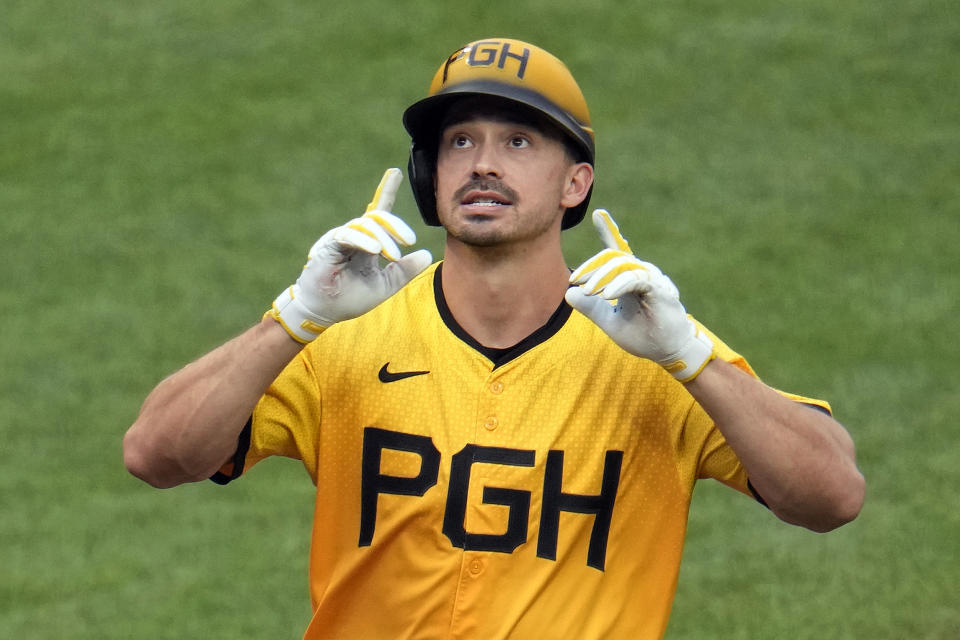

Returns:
123,169,431,488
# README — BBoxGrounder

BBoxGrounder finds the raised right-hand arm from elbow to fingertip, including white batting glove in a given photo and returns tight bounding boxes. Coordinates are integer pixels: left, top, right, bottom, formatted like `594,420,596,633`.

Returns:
566,209,864,531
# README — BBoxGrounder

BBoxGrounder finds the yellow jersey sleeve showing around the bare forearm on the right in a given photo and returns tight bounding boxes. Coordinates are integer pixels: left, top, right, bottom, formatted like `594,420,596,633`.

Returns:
684,320,832,502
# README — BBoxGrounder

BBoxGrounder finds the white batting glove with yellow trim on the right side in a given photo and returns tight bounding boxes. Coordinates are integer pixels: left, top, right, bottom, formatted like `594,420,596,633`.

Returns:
566,209,715,382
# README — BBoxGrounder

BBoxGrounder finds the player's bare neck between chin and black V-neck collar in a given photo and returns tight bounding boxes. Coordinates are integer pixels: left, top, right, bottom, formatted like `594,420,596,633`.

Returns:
442,234,570,349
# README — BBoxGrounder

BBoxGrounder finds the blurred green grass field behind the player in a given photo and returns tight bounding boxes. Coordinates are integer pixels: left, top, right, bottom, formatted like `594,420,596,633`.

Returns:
0,0,960,640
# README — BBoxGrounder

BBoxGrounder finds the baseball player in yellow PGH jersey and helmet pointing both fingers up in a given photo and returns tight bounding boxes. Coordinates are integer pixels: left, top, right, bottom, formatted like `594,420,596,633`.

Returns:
124,38,864,640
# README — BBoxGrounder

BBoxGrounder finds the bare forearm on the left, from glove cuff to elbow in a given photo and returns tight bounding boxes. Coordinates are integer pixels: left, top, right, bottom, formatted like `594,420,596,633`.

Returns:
123,318,303,487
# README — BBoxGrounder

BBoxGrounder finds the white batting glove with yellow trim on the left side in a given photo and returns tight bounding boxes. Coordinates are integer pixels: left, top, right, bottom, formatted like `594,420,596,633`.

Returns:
268,169,432,343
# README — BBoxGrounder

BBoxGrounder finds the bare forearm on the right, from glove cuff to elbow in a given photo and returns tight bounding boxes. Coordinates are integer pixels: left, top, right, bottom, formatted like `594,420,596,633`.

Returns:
686,359,864,531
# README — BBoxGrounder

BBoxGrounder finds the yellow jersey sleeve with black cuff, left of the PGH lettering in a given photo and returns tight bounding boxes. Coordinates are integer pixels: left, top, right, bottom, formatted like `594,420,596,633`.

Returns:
211,349,321,484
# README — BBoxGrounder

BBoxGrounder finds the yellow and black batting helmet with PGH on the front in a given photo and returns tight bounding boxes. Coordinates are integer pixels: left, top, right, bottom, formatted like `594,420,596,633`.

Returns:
403,38,594,229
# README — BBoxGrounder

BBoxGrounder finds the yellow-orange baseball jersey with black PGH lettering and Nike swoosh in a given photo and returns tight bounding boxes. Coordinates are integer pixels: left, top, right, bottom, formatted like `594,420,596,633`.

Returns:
214,265,825,640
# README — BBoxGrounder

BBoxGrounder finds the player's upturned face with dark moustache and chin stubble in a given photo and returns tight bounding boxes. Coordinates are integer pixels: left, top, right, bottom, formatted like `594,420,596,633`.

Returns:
436,107,592,246
